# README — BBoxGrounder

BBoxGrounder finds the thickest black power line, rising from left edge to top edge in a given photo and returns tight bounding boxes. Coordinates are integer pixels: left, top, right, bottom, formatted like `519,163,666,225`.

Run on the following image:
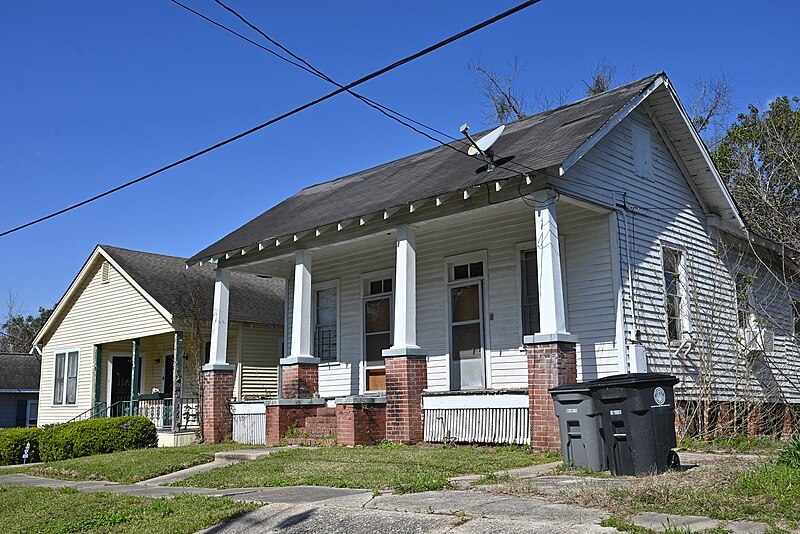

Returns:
0,0,540,237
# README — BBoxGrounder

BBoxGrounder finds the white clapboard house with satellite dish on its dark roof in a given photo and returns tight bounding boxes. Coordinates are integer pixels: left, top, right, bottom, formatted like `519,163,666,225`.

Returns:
189,73,800,448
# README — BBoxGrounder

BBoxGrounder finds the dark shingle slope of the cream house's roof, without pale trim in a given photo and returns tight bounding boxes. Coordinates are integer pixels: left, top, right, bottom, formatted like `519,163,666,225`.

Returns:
100,245,284,324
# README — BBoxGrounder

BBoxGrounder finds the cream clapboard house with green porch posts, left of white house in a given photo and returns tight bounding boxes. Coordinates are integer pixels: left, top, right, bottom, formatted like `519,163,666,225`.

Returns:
34,245,284,444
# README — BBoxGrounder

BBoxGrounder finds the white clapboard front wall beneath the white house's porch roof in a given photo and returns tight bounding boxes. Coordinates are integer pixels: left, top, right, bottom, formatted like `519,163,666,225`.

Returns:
287,200,617,397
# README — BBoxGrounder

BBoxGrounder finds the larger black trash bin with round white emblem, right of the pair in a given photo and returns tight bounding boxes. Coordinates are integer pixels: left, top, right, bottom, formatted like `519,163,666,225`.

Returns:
588,373,680,476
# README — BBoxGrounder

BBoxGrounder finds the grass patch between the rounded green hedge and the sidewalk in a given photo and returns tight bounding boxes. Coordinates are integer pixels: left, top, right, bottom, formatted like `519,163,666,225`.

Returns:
7,443,262,484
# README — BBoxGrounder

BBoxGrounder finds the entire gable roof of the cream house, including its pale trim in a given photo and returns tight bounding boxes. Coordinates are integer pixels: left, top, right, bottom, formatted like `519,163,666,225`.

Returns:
34,245,285,343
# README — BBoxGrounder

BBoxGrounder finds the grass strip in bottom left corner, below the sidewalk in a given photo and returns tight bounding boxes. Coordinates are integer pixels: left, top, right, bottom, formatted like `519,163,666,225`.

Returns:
0,486,257,534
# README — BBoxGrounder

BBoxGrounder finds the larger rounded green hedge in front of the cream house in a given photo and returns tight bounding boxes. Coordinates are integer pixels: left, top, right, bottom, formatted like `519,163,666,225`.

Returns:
40,416,158,462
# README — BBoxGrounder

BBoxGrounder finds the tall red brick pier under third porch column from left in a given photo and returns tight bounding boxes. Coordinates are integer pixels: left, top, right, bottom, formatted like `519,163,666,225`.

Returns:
385,355,428,444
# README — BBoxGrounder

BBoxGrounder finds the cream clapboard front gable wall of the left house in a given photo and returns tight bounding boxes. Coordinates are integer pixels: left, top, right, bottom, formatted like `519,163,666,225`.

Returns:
39,256,172,424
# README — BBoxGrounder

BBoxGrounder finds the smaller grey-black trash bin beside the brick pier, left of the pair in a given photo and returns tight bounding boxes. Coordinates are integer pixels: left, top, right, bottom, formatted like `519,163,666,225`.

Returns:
550,383,608,471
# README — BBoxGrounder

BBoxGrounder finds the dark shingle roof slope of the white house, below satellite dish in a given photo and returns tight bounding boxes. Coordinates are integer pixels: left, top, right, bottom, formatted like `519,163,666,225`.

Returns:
189,73,661,262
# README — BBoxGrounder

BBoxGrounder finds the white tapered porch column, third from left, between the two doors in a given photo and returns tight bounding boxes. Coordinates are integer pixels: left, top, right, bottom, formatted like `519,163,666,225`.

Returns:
383,225,422,356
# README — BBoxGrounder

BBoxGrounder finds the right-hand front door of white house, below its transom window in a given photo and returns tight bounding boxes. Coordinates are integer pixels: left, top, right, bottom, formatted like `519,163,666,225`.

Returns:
449,280,485,390
